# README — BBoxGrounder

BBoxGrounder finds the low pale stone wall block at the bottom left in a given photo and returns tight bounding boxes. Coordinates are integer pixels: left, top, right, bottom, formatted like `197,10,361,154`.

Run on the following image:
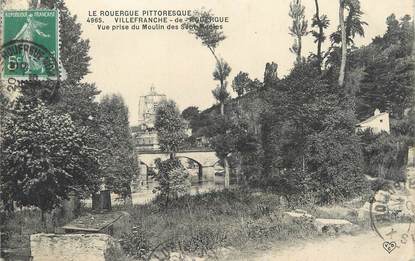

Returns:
30,234,125,261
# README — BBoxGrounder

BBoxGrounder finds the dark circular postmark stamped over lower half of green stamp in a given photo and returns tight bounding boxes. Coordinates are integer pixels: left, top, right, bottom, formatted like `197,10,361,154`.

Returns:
0,40,60,102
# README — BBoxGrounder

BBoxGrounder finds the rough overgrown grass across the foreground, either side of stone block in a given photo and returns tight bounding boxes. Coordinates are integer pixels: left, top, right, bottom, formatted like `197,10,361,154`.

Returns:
0,190,368,260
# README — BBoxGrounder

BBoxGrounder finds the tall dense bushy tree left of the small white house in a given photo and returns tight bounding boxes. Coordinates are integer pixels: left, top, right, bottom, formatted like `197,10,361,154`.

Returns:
306,96,369,203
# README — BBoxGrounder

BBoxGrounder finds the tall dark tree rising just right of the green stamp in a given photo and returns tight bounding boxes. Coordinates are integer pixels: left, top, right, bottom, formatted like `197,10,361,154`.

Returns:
42,0,108,201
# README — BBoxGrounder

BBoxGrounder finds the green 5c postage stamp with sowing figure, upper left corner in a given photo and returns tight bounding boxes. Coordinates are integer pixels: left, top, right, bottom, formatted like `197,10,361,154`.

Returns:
1,9,60,80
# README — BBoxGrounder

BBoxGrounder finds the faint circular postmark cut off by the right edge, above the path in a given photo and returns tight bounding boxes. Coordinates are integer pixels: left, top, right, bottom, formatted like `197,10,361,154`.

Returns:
369,175,415,254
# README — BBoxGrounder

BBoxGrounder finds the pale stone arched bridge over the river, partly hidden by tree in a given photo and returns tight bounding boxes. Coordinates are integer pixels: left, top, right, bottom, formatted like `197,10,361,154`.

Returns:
138,149,219,181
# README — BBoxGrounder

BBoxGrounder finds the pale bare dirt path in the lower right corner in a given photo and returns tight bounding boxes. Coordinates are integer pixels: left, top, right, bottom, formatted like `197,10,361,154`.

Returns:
227,224,415,261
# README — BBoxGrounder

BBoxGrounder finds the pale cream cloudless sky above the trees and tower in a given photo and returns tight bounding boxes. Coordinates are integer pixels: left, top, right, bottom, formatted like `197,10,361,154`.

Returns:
66,0,414,125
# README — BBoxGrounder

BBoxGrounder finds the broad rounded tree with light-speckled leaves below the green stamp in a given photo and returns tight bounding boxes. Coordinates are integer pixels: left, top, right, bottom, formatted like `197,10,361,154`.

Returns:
0,98,100,223
